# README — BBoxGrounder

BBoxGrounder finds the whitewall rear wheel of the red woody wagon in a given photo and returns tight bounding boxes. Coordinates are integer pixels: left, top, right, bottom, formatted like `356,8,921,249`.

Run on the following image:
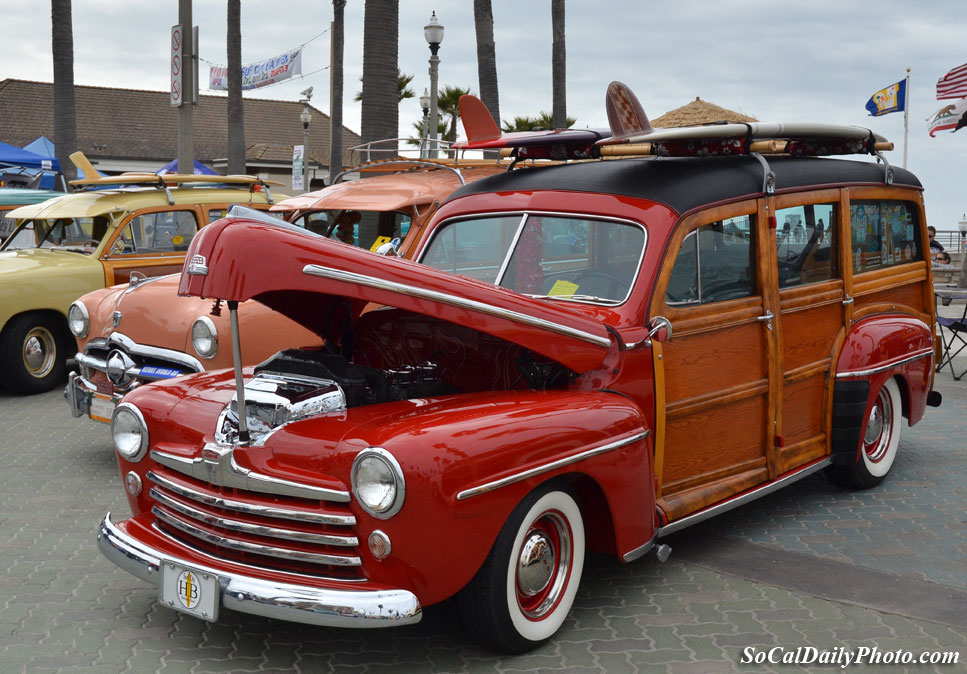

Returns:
828,378,903,489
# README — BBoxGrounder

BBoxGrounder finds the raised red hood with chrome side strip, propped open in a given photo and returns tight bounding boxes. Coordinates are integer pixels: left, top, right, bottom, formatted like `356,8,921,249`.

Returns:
178,218,617,372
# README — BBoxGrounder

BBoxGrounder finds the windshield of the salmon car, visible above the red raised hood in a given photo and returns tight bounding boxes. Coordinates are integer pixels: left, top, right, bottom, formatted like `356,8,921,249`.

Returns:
292,209,411,250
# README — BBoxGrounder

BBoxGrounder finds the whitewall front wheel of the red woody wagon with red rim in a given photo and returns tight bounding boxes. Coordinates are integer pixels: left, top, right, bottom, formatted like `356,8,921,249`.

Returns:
458,489,585,653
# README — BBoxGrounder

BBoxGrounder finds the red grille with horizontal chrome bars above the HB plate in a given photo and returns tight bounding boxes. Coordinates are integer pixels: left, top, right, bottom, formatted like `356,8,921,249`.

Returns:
147,467,362,580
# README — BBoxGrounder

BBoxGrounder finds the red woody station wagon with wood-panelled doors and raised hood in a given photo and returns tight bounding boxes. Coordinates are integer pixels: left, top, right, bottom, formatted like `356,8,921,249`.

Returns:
99,89,940,652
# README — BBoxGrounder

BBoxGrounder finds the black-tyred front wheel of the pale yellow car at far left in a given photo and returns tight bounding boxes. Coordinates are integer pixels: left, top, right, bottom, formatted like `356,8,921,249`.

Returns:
0,314,67,393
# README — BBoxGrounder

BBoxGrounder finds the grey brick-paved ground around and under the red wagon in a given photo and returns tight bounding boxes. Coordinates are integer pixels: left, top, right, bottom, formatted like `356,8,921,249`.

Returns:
0,338,967,674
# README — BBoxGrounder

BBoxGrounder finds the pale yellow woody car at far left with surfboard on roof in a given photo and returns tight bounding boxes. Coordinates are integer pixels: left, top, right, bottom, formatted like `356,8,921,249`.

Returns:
0,163,285,393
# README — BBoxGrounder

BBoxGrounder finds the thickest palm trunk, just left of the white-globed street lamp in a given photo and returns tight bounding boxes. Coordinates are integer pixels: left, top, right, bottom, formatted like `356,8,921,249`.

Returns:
360,0,400,154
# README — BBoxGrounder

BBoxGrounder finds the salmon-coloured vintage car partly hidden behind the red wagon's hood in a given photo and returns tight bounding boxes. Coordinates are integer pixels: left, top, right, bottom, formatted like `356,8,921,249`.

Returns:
65,162,506,423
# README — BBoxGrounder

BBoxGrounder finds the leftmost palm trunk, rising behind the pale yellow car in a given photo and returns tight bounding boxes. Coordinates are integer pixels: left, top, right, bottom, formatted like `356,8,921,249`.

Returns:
50,0,76,180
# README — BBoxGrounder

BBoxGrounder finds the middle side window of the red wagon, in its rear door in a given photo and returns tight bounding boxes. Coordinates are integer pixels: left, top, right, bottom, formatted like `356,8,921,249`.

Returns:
776,204,839,288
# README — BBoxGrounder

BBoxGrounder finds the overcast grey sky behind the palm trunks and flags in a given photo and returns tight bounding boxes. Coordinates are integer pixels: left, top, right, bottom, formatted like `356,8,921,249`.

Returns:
7,0,967,230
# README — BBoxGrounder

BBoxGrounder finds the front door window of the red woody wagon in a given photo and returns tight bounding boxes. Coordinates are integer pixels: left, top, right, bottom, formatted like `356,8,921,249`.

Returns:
665,215,755,304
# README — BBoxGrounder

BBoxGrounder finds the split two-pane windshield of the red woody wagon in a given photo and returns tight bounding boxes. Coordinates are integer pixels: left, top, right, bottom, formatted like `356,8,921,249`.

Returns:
421,214,645,305
